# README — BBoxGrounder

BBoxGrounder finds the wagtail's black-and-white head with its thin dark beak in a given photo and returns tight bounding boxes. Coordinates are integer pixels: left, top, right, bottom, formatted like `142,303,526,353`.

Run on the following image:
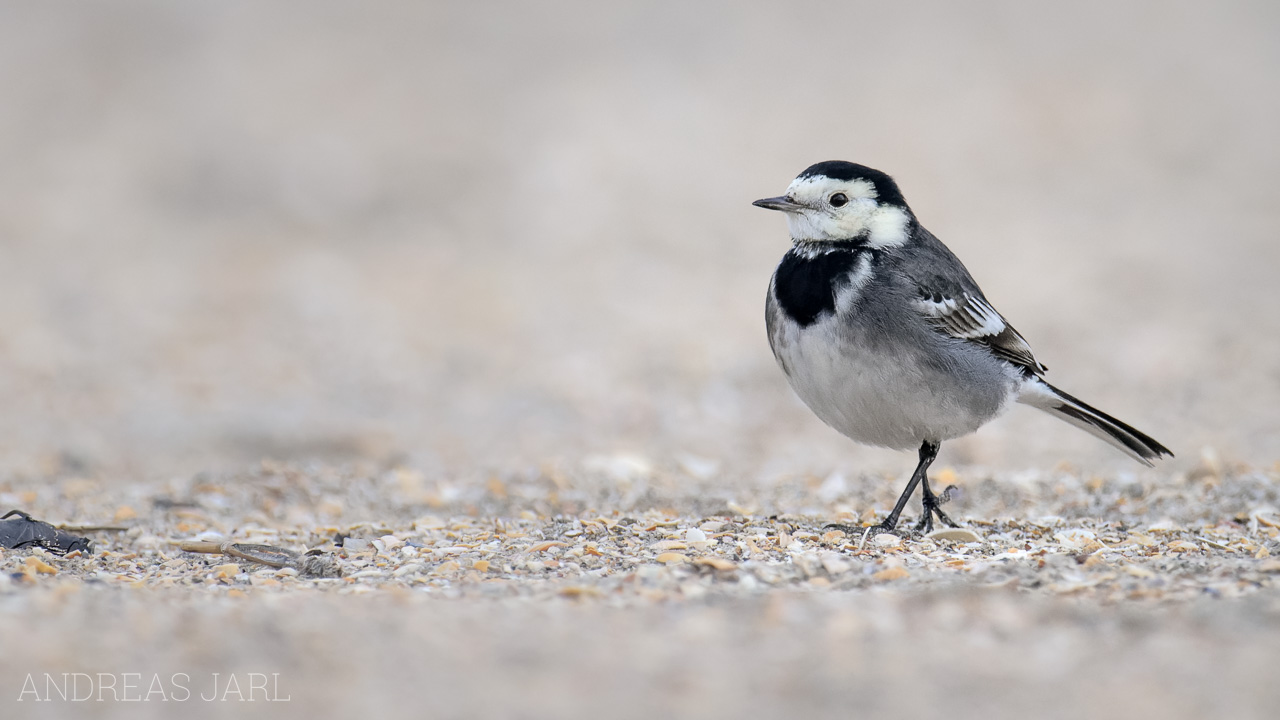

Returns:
753,160,914,247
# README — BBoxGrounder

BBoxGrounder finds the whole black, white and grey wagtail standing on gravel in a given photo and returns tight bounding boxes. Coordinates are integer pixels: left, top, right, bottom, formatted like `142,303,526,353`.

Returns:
753,160,1172,542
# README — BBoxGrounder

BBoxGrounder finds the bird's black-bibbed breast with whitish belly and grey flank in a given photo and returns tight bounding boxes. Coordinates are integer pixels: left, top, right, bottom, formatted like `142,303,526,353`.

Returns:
765,252,1015,448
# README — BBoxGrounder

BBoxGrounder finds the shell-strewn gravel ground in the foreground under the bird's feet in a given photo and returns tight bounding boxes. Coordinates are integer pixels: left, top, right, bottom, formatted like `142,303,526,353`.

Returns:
0,457,1280,717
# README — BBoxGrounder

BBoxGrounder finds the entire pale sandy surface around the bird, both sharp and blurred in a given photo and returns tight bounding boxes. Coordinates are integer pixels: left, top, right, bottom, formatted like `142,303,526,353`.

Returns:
0,3,1280,717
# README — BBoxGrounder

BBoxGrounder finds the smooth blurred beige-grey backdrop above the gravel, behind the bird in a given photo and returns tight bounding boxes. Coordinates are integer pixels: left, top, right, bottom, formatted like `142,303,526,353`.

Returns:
0,1,1280,483
